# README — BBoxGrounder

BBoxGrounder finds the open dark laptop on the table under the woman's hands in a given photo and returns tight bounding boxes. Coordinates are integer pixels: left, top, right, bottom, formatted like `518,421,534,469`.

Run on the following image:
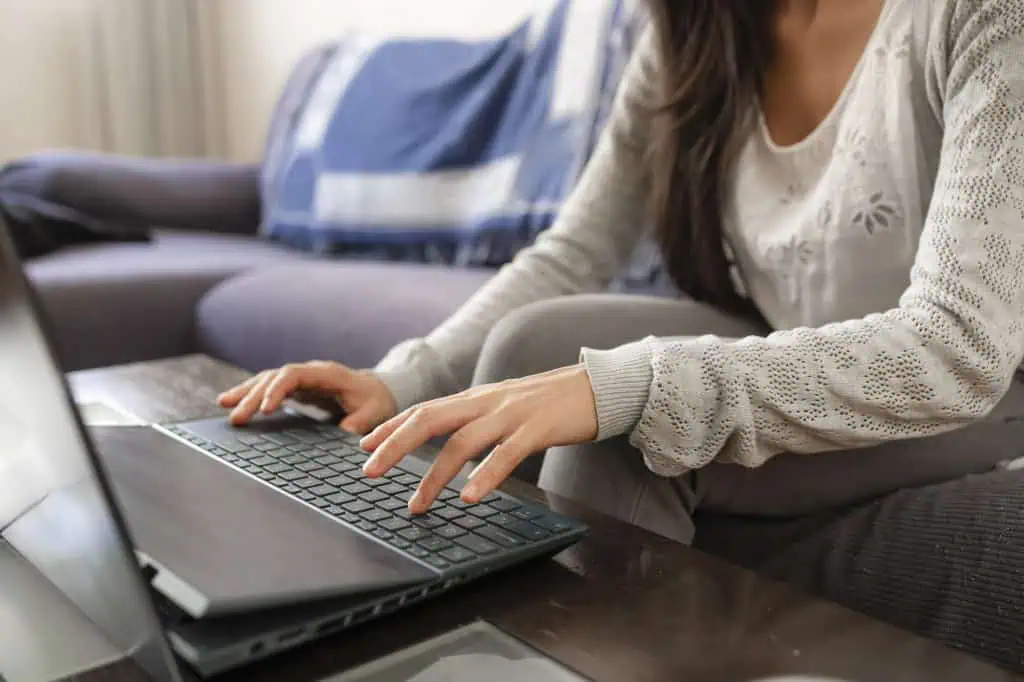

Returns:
0,218,587,680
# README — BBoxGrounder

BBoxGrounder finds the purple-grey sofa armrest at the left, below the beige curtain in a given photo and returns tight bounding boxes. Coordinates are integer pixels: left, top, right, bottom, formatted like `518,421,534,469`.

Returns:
0,152,261,235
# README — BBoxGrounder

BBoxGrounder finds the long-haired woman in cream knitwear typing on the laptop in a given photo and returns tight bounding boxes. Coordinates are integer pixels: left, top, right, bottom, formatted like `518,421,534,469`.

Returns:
221,0,1024,668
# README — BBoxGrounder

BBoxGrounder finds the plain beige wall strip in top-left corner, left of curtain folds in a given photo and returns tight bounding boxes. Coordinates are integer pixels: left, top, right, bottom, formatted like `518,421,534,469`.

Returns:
0,0,98,162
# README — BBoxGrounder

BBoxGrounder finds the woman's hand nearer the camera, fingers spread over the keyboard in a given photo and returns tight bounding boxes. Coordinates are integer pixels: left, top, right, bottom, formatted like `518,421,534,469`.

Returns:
360,365,597,514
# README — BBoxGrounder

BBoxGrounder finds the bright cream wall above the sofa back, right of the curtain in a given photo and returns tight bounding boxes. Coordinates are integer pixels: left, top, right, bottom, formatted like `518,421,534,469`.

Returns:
201,0,544,161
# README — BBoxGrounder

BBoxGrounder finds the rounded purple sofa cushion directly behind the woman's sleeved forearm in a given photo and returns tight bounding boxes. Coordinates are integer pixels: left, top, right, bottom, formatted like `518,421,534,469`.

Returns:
198,262,494,371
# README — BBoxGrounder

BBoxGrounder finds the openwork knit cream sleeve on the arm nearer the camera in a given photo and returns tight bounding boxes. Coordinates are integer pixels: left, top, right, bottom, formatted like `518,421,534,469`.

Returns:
584,0,1024,475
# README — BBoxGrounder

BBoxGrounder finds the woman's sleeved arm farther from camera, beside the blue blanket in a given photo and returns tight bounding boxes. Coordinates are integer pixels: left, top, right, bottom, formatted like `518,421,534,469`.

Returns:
377,33,655,410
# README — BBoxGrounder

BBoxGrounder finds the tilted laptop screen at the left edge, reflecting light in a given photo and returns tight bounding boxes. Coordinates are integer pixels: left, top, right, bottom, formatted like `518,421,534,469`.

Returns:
0,220,179,682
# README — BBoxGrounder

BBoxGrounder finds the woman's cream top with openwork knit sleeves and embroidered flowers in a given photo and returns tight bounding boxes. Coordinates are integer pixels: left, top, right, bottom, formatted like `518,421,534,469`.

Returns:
378,0,1024,475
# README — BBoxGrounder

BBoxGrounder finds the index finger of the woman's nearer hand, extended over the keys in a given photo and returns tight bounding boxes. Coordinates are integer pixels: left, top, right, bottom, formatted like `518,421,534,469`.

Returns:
364,398,483,476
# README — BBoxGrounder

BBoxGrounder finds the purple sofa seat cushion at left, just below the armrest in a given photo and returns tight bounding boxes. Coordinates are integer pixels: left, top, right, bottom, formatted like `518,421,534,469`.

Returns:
28,232,302,370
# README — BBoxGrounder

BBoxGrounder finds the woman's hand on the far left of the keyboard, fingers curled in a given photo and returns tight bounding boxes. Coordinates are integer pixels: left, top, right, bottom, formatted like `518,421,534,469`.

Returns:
217,361,397,434
